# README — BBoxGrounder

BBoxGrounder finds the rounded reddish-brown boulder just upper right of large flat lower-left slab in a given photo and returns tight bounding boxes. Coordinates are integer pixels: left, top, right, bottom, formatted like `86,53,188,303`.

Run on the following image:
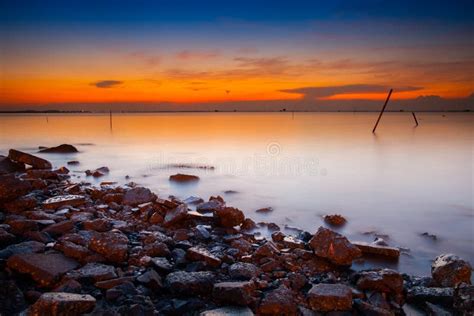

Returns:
89,231,128,263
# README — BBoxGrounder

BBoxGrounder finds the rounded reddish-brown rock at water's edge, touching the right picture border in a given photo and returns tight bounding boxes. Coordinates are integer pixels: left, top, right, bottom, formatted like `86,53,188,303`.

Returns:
431,254,471,287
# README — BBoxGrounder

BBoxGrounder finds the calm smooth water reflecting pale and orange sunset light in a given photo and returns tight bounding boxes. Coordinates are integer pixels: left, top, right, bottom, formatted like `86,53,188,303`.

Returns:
0,113,474,275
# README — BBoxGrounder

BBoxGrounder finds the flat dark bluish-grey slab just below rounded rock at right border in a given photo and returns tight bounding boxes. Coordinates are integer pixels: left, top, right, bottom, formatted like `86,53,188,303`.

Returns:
407,286,454,306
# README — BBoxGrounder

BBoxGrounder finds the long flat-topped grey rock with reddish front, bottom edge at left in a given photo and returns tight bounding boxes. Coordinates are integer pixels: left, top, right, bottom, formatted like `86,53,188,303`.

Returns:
28,292,96,316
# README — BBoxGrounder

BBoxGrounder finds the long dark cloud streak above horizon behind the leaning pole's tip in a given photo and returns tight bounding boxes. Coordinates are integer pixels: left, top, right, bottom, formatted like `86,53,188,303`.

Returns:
279,84,423,100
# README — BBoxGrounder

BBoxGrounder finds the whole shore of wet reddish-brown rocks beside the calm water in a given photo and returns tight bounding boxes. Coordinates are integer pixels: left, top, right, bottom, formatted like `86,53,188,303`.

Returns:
0,145,474,316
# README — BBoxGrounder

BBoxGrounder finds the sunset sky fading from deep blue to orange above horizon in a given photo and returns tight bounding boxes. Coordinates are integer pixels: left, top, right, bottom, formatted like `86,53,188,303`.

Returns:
0,0,474,111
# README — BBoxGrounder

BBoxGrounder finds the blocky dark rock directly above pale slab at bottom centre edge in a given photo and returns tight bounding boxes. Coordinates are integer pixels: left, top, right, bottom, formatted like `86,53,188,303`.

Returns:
212,282,255,306
